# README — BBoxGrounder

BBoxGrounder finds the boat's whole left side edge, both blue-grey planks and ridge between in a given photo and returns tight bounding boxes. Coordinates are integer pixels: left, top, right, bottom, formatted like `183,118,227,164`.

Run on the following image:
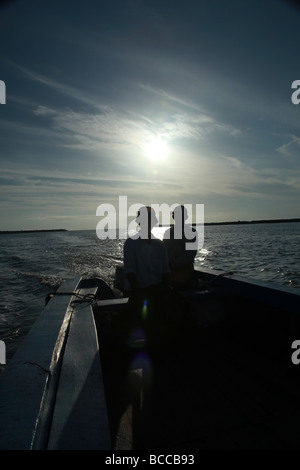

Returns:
0,280,111,450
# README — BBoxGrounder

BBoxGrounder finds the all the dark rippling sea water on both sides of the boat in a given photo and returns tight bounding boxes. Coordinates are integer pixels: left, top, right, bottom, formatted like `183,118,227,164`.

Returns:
0,222,300,367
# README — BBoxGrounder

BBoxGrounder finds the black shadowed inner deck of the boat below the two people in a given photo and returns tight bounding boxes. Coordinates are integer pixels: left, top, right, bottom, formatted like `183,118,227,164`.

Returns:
96,290,300,450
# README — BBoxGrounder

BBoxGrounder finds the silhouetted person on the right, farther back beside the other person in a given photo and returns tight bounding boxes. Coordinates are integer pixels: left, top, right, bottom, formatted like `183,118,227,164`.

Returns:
163,206,198,288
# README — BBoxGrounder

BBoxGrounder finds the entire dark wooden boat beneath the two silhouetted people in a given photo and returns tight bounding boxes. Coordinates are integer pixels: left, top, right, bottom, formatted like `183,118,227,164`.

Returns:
0,270,300,450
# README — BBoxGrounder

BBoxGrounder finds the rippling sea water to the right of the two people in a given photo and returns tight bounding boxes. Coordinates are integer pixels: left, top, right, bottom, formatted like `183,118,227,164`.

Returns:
196,223,300,287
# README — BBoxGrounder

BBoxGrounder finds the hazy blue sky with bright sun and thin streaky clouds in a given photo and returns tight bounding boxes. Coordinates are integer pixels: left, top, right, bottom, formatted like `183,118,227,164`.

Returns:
0,0,300,230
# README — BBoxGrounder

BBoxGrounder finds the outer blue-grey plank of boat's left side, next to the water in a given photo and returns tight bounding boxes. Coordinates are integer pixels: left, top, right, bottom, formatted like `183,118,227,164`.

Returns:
0,279,80,450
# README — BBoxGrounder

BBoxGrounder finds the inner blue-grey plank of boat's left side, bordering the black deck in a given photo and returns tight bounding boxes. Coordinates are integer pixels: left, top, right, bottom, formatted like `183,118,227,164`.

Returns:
47,278,111,450
